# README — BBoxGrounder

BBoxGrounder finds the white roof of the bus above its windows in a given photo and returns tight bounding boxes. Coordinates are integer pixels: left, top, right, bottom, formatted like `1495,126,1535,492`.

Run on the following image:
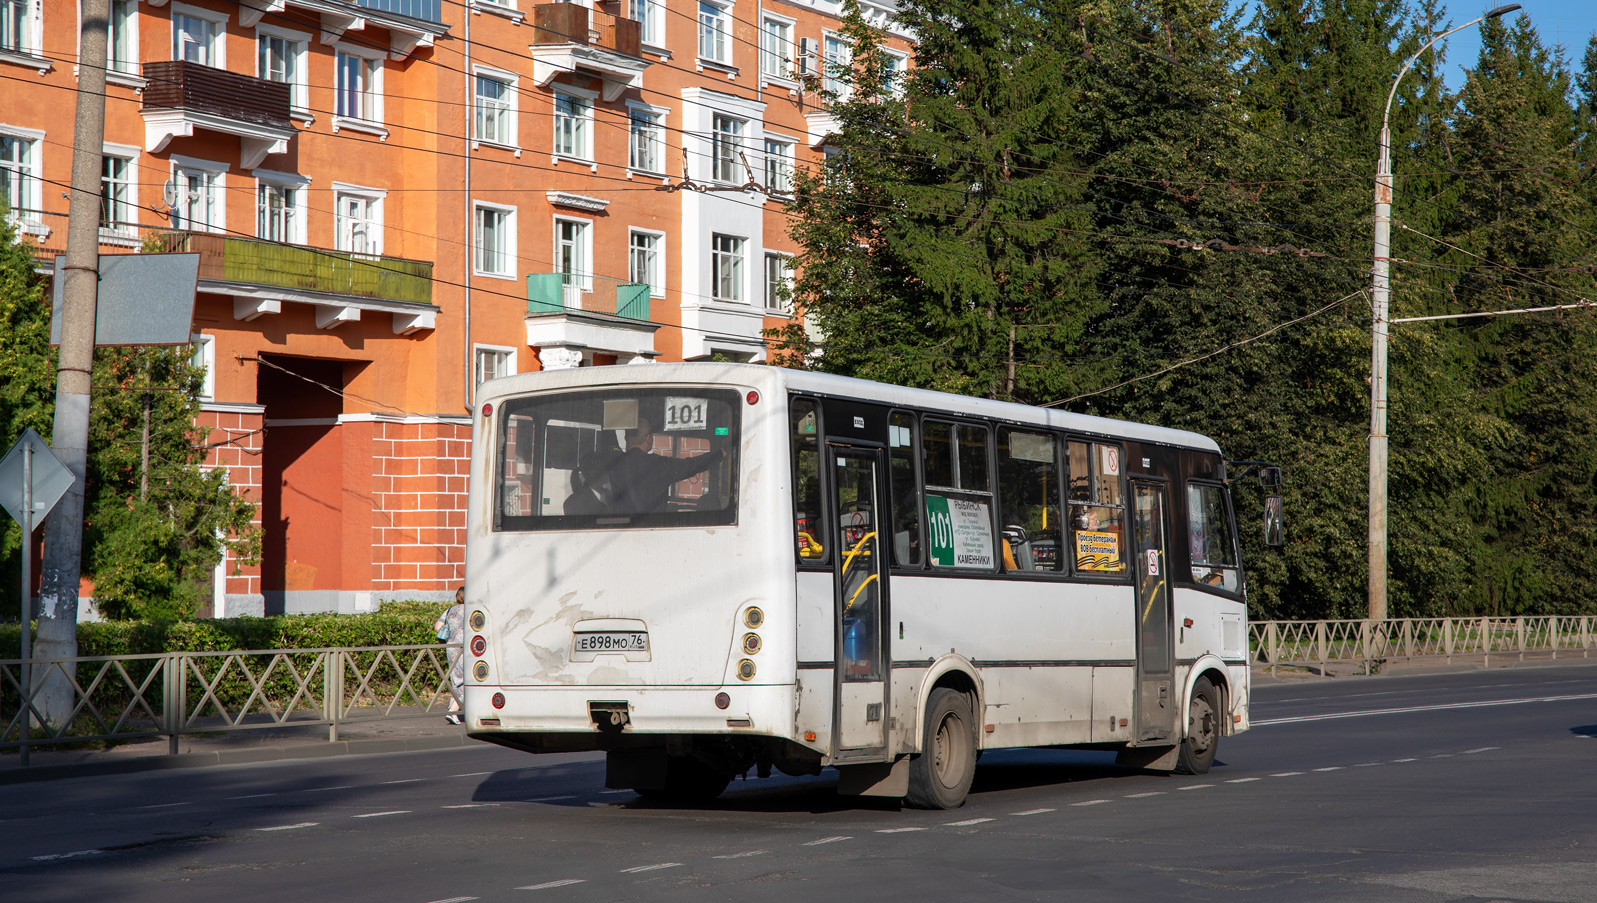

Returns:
478,361,1220,454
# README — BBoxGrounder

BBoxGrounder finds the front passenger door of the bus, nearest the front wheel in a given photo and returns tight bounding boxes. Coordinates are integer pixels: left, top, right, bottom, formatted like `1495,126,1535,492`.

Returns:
1131,481,1180,743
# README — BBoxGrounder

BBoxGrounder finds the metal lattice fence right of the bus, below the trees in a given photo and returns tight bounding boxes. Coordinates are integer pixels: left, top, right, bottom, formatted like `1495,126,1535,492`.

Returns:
1249,615,1597,674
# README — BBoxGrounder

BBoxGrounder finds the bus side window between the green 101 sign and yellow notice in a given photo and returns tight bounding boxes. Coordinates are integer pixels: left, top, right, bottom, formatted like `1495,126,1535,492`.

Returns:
998,430,1064,572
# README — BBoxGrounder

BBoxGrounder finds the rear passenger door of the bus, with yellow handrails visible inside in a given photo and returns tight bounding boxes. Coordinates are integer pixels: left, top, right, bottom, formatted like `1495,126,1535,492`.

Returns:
829,444,893,762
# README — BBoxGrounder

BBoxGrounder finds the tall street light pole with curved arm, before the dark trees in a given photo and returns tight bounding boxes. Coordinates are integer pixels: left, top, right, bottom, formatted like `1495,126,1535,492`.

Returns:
1369,3,1520,620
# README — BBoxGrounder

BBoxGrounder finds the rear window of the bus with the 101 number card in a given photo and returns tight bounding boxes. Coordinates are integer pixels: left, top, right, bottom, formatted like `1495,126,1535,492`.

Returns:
495,387,739,532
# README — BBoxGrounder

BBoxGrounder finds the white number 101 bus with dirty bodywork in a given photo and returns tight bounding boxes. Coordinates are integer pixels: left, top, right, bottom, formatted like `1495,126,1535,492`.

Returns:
465,363,1279,809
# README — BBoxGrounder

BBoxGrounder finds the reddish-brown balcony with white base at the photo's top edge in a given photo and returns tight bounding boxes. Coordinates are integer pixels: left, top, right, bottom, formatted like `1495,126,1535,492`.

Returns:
527,3,648,101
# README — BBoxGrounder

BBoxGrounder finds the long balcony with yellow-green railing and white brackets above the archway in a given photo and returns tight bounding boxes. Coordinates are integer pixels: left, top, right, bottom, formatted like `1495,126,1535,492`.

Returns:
153,232,438,336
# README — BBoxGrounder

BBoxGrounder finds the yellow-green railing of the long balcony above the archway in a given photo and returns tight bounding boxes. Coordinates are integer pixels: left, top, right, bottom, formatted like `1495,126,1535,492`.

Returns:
155,232,433,304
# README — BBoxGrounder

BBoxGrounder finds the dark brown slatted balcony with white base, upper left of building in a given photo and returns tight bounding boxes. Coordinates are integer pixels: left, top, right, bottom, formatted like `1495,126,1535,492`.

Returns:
139,59,294,169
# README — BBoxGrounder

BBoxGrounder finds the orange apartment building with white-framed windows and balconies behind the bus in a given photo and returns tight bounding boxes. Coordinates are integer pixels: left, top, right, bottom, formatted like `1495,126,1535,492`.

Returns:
0,0,909,615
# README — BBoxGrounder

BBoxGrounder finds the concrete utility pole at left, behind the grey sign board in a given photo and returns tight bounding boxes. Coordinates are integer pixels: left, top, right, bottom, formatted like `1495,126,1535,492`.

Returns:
34,0,110,724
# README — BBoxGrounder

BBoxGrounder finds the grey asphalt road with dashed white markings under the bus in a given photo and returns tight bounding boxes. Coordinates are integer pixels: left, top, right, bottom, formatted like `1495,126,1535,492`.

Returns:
0,665,1597,903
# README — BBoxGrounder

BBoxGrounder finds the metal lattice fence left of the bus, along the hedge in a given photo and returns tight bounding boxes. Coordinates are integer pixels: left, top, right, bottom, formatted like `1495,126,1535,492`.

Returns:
0,644,449,766
